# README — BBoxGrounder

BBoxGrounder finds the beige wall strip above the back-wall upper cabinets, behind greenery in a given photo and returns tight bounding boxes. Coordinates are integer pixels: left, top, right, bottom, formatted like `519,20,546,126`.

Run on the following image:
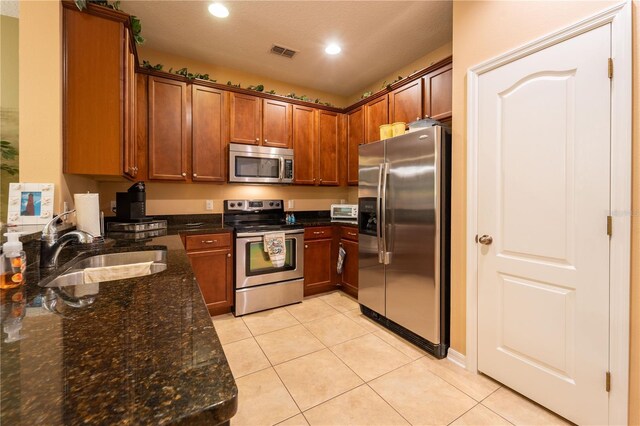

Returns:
138,45,347,108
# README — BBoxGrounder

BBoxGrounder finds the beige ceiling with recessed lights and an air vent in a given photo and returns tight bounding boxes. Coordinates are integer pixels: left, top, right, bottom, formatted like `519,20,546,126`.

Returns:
121,0,452,96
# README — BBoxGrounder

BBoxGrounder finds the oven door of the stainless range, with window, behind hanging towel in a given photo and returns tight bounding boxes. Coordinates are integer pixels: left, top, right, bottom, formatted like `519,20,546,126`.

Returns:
236,231,304,289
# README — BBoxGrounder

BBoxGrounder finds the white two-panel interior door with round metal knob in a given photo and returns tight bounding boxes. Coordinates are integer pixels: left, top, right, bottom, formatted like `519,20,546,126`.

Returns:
477,24,611,424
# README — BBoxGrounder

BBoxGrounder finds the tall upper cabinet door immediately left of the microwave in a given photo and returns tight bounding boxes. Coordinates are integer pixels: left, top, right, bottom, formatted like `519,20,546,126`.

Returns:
191,84,226,182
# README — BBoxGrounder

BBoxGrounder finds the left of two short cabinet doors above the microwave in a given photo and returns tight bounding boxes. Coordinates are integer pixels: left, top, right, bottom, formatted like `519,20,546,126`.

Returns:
229,92,262,145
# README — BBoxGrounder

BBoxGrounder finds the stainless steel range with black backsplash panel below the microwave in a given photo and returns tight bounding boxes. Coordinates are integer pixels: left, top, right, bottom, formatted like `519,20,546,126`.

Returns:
224,200,304,316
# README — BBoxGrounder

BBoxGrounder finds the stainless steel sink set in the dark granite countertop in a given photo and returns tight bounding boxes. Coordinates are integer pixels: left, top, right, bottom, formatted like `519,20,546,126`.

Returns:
40,250,167,287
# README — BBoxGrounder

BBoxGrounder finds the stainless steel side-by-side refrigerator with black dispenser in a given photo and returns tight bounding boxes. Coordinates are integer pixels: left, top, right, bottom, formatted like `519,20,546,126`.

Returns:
358,126,451,358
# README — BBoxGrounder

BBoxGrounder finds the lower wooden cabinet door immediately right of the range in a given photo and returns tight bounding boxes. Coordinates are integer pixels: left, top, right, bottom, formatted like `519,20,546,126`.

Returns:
304,239,334,296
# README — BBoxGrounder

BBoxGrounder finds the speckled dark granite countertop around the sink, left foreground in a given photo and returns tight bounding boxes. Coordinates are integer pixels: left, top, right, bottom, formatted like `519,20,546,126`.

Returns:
0,225,237,425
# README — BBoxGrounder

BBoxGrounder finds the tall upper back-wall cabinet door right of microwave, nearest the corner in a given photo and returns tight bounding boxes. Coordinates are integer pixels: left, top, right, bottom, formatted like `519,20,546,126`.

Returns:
317,110,340,185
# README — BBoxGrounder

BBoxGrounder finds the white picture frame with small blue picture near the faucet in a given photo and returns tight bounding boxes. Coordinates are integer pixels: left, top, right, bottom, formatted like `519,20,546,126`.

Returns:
7,182,54,225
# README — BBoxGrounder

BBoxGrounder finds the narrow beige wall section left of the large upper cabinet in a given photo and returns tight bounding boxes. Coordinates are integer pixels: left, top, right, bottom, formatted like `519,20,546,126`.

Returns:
19,0,97,212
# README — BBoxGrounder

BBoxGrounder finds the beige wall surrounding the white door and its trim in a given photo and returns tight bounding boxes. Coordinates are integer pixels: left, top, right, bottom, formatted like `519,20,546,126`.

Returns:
451,0,640,424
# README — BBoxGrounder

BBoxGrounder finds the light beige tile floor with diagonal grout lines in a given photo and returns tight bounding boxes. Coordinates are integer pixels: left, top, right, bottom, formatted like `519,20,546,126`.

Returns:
213,292,570,426
